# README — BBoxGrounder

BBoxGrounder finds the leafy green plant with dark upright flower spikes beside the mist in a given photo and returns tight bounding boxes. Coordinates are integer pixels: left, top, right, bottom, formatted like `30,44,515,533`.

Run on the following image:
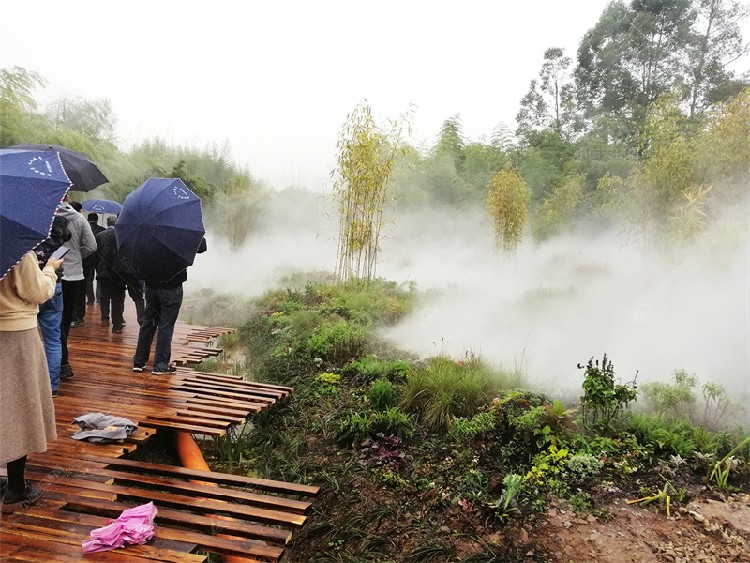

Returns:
578,354,637,433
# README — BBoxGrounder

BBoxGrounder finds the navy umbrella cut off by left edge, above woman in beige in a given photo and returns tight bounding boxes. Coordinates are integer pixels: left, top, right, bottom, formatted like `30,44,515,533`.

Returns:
0,149,71,279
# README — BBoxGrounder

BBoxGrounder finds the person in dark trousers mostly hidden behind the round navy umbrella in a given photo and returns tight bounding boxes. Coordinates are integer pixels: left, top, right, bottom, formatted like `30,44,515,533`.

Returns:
133,238,207,375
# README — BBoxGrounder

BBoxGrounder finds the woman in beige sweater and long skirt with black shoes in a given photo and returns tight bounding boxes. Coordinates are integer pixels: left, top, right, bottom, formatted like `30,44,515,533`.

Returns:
0,252,63,514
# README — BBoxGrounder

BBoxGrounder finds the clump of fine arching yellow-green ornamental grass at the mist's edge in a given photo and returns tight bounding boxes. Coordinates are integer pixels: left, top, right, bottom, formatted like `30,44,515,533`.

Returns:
401,356,520,431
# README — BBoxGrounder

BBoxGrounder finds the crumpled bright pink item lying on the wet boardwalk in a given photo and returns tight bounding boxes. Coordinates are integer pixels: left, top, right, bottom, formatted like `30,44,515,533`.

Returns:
81,502,156,553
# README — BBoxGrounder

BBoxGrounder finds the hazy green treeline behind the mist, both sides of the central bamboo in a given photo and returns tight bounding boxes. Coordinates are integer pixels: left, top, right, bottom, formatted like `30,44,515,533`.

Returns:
0,0,750,248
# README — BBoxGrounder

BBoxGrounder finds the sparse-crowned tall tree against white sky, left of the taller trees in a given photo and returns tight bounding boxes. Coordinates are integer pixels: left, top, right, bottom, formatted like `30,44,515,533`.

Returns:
516,47,576,140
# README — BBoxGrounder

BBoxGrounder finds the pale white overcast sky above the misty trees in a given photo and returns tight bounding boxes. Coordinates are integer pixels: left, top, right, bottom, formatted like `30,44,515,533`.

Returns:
0,0,624,189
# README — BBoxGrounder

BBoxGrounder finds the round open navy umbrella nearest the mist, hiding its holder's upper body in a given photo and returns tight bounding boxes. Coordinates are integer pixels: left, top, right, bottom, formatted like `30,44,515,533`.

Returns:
115,178,206,281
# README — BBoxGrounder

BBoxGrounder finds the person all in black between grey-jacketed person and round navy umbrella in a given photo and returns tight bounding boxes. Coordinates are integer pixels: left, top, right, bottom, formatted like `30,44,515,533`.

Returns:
96,217,125,333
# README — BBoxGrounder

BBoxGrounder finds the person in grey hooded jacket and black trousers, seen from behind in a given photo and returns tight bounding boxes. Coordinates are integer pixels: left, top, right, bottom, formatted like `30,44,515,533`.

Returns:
57,196,96,379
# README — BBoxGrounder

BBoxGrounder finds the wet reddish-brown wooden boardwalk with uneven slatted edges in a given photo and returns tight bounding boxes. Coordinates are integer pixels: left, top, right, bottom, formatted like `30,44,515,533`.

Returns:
0,300,318,562
